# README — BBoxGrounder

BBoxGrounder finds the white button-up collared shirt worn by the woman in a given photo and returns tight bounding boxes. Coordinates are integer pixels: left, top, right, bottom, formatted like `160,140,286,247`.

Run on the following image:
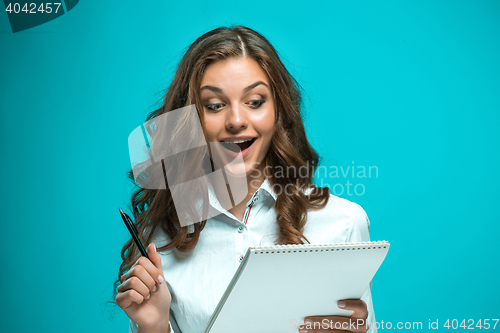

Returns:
130,179,376,333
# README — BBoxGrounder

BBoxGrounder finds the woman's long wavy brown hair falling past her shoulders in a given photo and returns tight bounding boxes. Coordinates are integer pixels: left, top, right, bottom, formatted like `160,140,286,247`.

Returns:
113,26,330,299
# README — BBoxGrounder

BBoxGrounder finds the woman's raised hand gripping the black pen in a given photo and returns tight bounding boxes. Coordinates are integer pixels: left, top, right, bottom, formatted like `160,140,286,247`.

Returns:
116,243,172,332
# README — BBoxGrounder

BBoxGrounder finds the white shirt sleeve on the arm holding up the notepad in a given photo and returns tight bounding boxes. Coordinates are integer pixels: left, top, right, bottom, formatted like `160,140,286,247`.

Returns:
347,203,377,333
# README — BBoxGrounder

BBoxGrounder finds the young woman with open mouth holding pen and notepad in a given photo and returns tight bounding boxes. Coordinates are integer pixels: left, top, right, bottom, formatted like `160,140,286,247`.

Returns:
115,26,375,333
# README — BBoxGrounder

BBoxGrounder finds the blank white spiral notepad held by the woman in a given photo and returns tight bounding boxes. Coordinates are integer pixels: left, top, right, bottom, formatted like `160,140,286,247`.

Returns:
204,241,390,333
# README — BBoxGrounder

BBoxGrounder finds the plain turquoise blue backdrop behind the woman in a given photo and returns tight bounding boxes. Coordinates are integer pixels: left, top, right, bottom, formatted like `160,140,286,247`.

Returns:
0,0,500,332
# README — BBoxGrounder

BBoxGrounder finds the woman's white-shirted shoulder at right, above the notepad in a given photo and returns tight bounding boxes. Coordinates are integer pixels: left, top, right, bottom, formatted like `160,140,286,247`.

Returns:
306,193,370,242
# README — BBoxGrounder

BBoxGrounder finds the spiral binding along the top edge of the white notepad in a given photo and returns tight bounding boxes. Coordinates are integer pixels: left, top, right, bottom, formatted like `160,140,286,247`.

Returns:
252,241,390,254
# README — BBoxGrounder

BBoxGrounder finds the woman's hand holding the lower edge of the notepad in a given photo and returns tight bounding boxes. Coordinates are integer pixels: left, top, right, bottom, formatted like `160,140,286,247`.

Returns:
299,299,368,333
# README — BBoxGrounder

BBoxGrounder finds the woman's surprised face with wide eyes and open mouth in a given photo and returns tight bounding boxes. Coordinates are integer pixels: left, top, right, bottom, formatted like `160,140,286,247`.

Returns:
201,57,275,175
